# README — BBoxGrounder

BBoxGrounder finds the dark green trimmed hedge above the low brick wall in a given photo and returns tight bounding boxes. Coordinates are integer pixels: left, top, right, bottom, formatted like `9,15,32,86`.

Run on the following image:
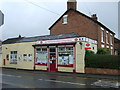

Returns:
85,54,120,70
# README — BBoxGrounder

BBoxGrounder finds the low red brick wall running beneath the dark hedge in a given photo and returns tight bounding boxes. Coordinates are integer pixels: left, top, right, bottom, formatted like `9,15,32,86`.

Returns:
85,68,120,75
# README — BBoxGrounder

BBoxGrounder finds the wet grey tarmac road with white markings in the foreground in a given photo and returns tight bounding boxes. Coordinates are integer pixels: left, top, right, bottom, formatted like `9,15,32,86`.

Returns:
0,69,120,88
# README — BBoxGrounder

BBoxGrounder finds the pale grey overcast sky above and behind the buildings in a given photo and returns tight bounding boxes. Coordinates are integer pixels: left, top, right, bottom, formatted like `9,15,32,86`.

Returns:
0,0,118,40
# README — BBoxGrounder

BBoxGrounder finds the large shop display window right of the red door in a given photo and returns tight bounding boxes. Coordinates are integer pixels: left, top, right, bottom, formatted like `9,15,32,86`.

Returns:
58,45,74,65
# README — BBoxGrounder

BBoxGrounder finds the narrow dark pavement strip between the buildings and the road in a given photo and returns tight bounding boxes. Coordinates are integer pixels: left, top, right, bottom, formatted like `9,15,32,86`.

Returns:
3,68,120,81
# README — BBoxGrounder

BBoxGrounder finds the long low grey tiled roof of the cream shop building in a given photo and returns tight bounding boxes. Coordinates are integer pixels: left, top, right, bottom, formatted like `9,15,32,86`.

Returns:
2,32,80,44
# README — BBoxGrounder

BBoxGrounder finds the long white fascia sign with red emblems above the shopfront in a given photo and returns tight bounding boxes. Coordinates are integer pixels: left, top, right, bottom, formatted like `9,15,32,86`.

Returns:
36,38,80,44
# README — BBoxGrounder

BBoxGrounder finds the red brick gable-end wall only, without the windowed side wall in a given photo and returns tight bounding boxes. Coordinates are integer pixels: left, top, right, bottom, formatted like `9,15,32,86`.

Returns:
50,10,98,40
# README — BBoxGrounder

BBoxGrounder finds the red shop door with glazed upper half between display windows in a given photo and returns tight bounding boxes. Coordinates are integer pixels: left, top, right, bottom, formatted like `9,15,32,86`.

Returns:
49,48,56,72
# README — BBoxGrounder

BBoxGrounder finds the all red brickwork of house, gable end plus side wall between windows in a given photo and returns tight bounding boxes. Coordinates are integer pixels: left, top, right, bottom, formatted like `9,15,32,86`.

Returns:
50,10,114,52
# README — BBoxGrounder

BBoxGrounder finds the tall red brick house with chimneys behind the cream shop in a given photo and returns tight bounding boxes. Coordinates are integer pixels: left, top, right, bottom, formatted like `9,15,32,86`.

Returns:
49,0,115,54
